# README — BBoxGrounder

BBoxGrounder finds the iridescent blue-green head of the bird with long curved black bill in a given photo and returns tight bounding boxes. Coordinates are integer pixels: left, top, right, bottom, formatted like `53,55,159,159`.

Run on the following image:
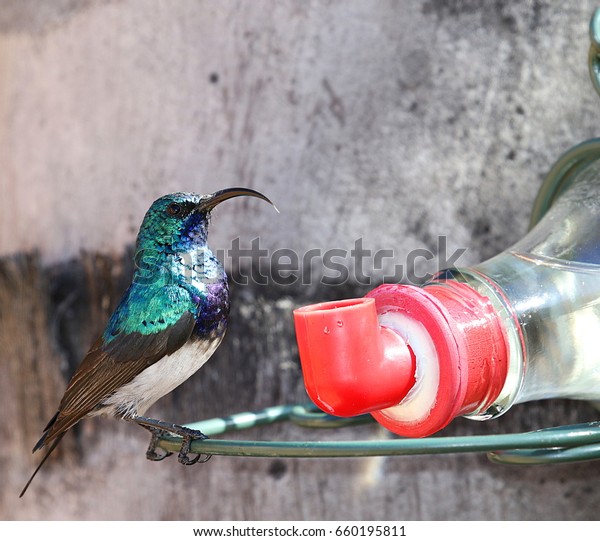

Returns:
137,188,274,252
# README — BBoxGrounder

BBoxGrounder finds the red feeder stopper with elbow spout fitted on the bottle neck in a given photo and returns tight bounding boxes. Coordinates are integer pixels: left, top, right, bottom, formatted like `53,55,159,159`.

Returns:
294,282,508,437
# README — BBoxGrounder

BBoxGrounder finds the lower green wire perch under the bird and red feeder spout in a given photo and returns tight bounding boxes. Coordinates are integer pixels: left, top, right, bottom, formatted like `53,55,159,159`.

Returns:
154,404,600,465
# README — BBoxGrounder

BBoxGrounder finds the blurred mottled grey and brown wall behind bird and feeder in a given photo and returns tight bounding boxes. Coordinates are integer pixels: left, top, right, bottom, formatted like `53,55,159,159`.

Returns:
0,0,600,520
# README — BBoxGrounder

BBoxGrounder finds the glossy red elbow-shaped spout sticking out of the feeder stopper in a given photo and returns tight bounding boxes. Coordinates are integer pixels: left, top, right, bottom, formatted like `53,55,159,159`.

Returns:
294,298,415,417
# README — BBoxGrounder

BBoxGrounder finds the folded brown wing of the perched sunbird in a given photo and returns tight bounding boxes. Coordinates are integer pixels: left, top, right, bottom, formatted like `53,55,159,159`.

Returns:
33,312,195,451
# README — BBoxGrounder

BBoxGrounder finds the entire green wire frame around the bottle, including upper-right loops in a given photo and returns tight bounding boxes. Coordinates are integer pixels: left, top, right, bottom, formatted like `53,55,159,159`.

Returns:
158,9,600,465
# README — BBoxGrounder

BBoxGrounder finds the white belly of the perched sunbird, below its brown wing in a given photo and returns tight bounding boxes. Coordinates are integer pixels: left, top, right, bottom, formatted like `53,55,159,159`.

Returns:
95,336,222,417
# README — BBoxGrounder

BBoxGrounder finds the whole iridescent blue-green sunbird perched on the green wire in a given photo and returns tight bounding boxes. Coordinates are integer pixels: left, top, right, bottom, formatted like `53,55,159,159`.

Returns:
21,188,270,496
